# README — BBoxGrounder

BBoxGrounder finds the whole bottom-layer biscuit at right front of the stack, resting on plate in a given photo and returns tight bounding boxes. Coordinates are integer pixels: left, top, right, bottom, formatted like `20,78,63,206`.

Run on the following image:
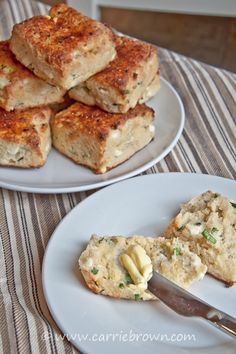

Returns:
51,102,155,173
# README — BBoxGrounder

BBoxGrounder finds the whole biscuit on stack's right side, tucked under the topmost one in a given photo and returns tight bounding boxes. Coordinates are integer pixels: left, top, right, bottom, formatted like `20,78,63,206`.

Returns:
69,36,160,113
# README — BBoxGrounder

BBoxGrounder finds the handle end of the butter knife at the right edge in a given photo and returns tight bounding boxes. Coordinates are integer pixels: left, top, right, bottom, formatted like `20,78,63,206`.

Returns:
207,309,236,339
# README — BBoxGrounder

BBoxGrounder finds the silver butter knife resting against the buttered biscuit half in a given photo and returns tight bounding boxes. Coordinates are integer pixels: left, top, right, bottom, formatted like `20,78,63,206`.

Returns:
148,272,236,339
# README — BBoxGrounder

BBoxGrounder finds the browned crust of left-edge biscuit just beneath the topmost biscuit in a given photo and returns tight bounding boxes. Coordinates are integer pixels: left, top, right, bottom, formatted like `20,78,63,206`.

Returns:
0,41,41,81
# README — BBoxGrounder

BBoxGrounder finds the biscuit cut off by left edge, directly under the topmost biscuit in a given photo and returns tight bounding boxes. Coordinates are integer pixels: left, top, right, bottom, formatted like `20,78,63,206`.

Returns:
0,41,65,111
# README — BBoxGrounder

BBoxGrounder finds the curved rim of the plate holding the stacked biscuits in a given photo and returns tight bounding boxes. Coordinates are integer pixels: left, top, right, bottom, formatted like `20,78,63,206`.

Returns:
0,77,185,194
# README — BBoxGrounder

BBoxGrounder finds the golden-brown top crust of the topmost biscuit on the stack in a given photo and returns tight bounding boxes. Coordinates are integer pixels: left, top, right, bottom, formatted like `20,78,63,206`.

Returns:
13,4,113,70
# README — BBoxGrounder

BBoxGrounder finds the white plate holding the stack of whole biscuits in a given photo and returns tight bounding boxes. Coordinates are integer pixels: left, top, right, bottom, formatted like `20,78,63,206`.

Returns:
0,79,184,193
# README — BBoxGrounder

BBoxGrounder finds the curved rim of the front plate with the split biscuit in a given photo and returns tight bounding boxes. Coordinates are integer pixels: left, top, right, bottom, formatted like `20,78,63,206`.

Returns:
41,172,236,353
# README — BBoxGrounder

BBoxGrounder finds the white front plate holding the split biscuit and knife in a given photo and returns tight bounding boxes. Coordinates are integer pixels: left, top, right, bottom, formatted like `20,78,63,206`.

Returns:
43,173,236,354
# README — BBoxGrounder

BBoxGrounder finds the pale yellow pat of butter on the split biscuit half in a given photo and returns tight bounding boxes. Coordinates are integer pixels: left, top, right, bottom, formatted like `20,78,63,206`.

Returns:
120,245,153,289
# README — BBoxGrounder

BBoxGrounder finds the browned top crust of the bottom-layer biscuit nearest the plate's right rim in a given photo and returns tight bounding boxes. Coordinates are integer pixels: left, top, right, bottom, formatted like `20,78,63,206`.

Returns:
53,102,154,140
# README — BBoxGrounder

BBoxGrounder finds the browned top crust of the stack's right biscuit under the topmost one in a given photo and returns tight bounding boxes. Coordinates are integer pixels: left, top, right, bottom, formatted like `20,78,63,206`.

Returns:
88,36,157,90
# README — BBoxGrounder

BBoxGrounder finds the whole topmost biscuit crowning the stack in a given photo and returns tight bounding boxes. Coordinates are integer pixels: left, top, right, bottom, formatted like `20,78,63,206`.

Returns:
10,4,116,90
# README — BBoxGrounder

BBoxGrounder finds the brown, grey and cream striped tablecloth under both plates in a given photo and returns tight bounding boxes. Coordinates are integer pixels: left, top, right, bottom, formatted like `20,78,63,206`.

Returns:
0,0,236,354
